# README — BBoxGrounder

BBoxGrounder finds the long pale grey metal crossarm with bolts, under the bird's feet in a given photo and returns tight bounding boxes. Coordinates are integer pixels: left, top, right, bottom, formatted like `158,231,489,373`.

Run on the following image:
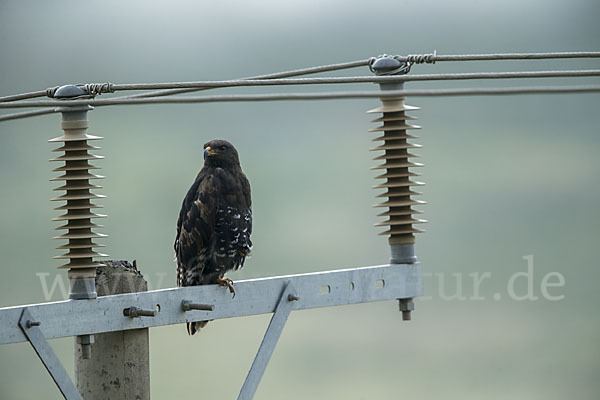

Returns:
0,263,421,344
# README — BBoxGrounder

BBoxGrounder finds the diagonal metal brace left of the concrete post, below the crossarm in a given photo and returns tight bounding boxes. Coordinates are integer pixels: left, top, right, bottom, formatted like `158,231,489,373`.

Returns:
19,308,83,400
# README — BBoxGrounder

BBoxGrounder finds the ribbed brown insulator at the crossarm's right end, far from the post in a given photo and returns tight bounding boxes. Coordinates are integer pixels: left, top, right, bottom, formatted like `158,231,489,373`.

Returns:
368,98,426,245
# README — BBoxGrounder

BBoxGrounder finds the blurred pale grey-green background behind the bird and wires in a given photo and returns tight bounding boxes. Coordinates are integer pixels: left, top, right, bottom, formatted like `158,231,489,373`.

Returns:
0,0,600,400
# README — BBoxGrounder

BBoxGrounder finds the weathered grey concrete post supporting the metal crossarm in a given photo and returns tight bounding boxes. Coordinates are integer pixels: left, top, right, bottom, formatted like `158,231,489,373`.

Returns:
75,261,150,400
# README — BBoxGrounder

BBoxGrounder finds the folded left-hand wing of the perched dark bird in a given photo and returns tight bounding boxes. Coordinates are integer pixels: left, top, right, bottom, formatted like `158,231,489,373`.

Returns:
174,173,216,286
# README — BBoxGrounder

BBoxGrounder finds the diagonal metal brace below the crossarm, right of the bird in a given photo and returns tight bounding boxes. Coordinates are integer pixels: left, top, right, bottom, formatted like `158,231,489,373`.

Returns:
238,281,300,400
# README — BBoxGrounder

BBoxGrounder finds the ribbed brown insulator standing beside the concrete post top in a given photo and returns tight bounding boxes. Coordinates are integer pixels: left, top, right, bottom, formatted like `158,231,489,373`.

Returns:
49,120,106,273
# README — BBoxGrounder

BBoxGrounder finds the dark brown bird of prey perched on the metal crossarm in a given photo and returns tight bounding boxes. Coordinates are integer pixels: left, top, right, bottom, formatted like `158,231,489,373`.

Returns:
175,139,252,335
